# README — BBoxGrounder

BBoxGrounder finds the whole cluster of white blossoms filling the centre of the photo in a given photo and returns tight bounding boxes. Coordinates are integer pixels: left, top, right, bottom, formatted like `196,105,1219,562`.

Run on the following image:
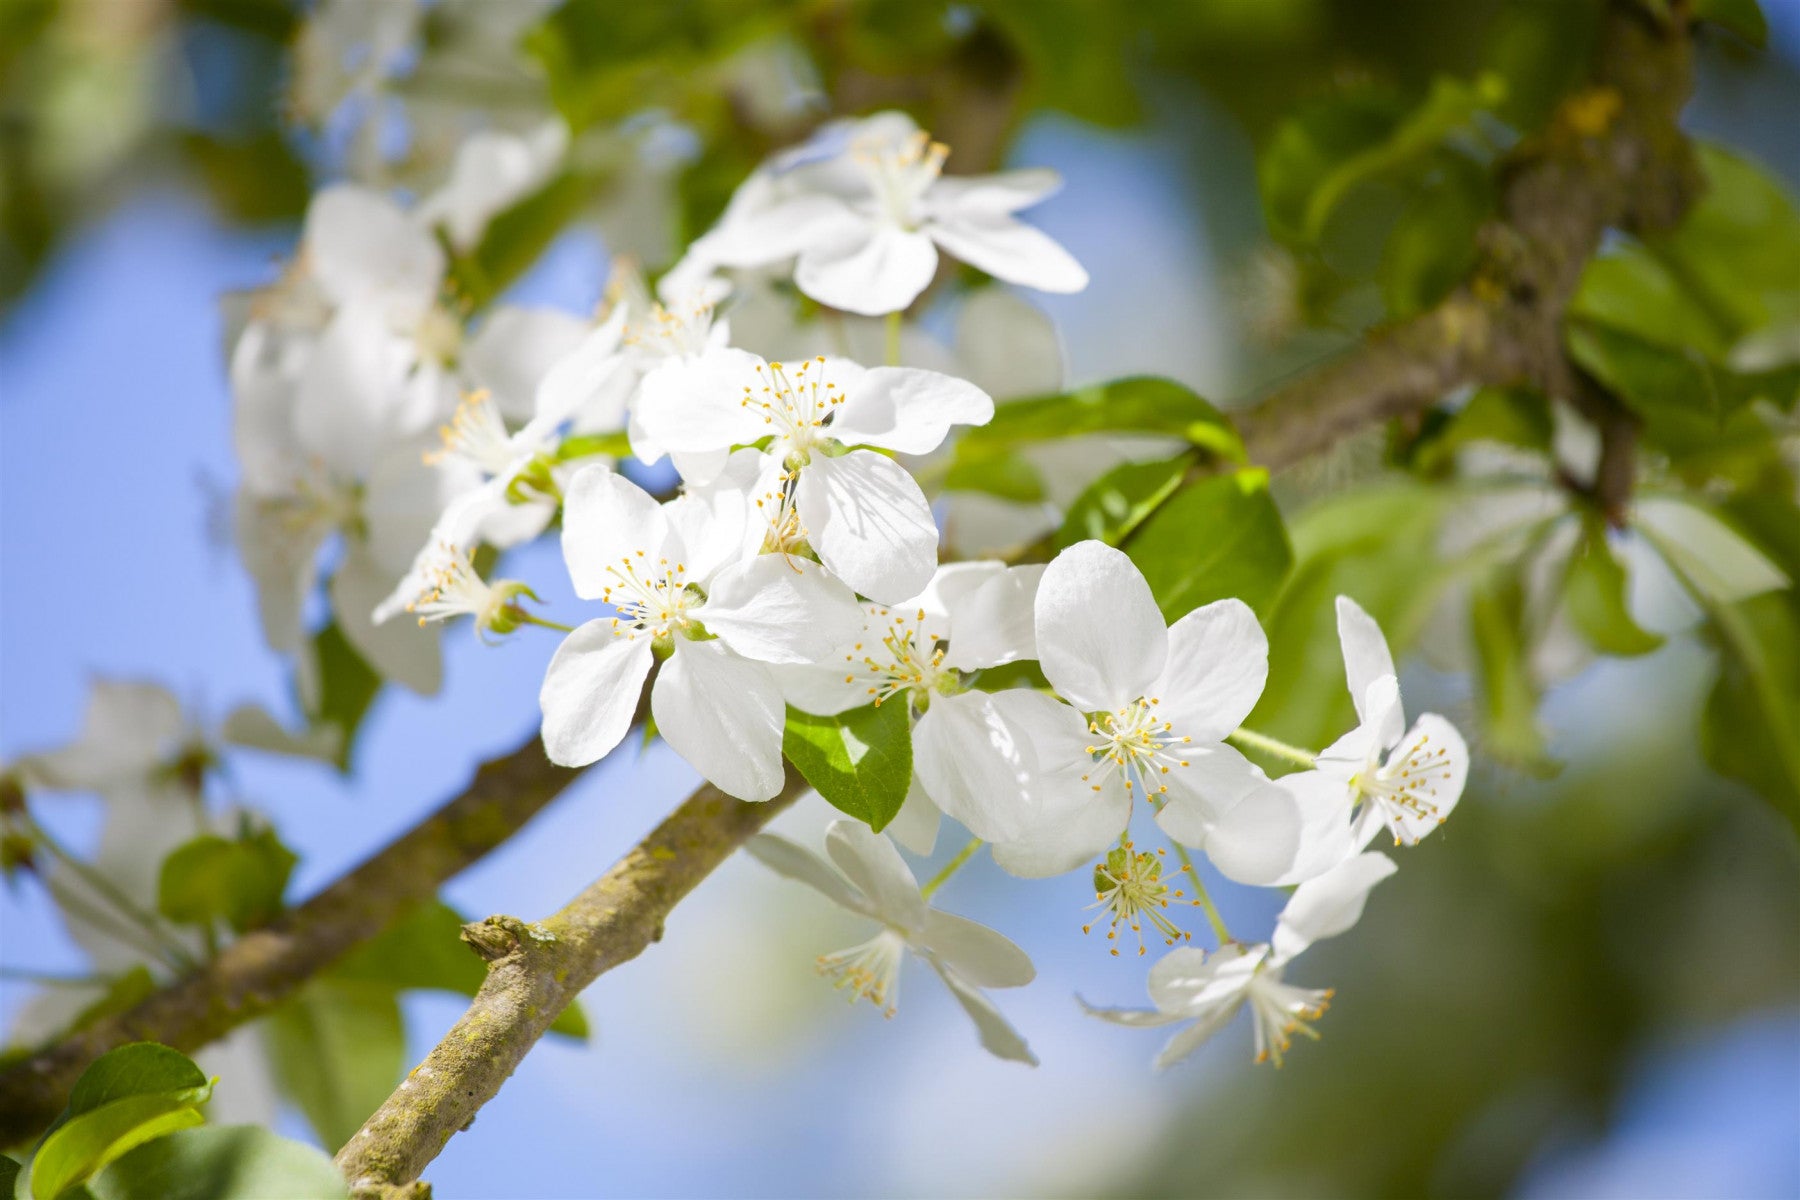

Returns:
214,105,1467,1061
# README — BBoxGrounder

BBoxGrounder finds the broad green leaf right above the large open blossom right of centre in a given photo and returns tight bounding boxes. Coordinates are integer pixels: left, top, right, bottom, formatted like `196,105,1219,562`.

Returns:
1123,470,1294,621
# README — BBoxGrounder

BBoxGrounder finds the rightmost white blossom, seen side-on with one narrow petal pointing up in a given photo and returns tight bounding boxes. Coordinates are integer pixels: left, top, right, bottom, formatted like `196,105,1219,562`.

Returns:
1276,596,1469,871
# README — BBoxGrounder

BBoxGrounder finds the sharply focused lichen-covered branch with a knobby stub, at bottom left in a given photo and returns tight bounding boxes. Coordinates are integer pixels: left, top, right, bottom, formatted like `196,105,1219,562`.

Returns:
337,770,805,1196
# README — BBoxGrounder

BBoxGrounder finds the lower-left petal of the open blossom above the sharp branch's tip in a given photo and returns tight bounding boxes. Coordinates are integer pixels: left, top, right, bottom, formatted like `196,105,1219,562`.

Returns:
538,617,655,766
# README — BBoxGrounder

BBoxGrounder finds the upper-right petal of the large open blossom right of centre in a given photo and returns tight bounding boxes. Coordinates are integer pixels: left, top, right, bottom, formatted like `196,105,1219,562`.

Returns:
1150,599,1269,741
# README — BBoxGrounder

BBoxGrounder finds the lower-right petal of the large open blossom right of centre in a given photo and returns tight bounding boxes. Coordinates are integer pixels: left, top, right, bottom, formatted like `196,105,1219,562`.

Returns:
1156,747,1300,885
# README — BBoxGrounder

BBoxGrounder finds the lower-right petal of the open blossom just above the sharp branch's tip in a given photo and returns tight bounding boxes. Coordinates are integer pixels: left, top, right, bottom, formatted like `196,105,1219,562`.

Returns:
650,639,787,801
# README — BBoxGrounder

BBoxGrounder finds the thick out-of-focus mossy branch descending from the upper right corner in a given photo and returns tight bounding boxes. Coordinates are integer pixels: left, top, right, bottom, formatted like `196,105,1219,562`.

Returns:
1238,0,1699,474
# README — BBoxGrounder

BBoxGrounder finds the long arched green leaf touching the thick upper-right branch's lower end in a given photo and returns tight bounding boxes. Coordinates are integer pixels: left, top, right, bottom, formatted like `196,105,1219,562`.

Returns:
950,376,1244,498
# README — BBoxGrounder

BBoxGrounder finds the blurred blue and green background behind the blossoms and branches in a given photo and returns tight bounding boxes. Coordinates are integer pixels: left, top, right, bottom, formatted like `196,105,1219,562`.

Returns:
0,0,1800,1200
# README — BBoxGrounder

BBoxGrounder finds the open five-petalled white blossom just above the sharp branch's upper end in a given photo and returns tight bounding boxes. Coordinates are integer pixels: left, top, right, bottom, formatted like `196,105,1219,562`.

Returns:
540,466,862,801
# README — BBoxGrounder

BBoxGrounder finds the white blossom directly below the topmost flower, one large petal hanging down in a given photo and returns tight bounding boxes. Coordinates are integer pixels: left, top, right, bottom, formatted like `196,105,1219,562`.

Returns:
639,351,994,603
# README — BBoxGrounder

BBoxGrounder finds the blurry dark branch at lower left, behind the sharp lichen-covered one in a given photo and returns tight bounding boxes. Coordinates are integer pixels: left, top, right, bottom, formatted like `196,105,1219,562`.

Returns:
0,734,580,1146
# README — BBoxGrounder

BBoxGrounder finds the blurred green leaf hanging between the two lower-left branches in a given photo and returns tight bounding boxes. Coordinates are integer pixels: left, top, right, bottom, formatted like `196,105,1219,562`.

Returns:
263,979,407,1148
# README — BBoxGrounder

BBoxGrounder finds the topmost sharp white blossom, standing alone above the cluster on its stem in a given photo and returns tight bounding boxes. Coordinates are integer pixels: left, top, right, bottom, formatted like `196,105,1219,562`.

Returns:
689,112,1087,315
